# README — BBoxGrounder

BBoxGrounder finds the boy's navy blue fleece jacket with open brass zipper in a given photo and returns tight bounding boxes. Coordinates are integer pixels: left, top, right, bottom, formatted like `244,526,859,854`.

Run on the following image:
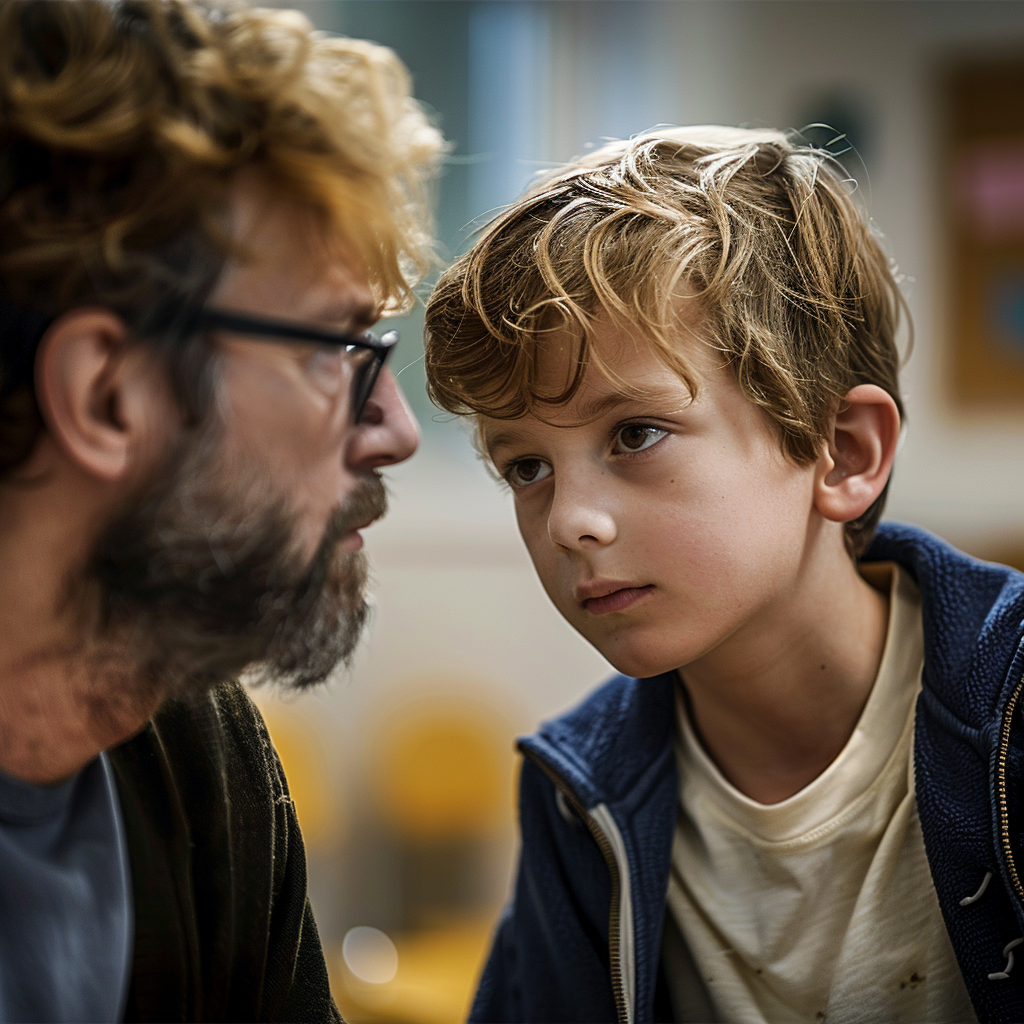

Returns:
470,524,1024,1024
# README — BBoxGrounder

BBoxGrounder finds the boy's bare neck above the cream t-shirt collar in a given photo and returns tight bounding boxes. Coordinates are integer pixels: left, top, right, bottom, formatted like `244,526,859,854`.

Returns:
682,552,889,804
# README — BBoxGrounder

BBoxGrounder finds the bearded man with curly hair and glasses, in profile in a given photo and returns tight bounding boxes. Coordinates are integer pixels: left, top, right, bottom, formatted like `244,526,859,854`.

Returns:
0,0,440,1021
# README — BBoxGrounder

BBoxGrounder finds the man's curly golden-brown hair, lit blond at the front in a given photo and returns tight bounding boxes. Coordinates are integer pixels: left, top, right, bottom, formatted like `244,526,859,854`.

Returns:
0,0,442,475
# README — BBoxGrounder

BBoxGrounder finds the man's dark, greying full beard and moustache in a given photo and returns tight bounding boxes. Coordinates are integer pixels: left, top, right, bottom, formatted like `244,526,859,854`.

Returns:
81,428,386,701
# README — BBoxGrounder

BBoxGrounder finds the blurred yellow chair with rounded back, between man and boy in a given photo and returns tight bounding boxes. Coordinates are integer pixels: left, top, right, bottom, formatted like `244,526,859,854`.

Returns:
329,700,512,1024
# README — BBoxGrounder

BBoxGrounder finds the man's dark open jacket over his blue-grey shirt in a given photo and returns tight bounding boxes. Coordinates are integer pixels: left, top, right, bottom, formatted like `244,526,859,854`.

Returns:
110,683,341,1021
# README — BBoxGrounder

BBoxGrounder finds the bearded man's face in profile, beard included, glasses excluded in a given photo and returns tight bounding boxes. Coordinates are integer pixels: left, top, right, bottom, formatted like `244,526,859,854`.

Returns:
91,183,418,692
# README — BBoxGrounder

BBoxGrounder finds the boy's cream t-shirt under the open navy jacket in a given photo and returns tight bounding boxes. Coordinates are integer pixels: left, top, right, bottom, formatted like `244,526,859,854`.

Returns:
669,565,976,1024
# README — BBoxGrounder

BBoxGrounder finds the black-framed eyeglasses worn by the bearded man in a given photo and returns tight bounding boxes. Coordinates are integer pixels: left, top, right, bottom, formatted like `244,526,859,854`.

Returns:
197,306,398,423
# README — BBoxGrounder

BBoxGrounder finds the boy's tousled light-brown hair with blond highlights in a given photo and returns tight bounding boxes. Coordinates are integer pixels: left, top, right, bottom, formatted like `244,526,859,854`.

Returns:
426,126,906,556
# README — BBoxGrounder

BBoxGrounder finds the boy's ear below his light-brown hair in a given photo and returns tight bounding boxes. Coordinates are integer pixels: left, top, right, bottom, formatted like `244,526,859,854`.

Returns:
814,384,900,522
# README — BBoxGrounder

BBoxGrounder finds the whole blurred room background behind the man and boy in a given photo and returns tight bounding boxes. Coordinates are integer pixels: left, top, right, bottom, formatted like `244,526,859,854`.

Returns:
256,0,1024,1024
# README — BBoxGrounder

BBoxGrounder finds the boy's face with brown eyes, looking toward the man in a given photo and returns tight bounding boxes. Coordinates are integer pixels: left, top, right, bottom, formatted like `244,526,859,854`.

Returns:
480,324,821,677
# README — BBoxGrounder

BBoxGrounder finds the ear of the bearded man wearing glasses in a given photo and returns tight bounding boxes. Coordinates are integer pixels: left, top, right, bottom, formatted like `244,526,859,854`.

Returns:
36,308,174,482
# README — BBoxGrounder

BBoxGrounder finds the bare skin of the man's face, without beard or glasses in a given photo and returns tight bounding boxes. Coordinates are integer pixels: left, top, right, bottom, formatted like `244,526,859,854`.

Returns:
208,183,419,556
